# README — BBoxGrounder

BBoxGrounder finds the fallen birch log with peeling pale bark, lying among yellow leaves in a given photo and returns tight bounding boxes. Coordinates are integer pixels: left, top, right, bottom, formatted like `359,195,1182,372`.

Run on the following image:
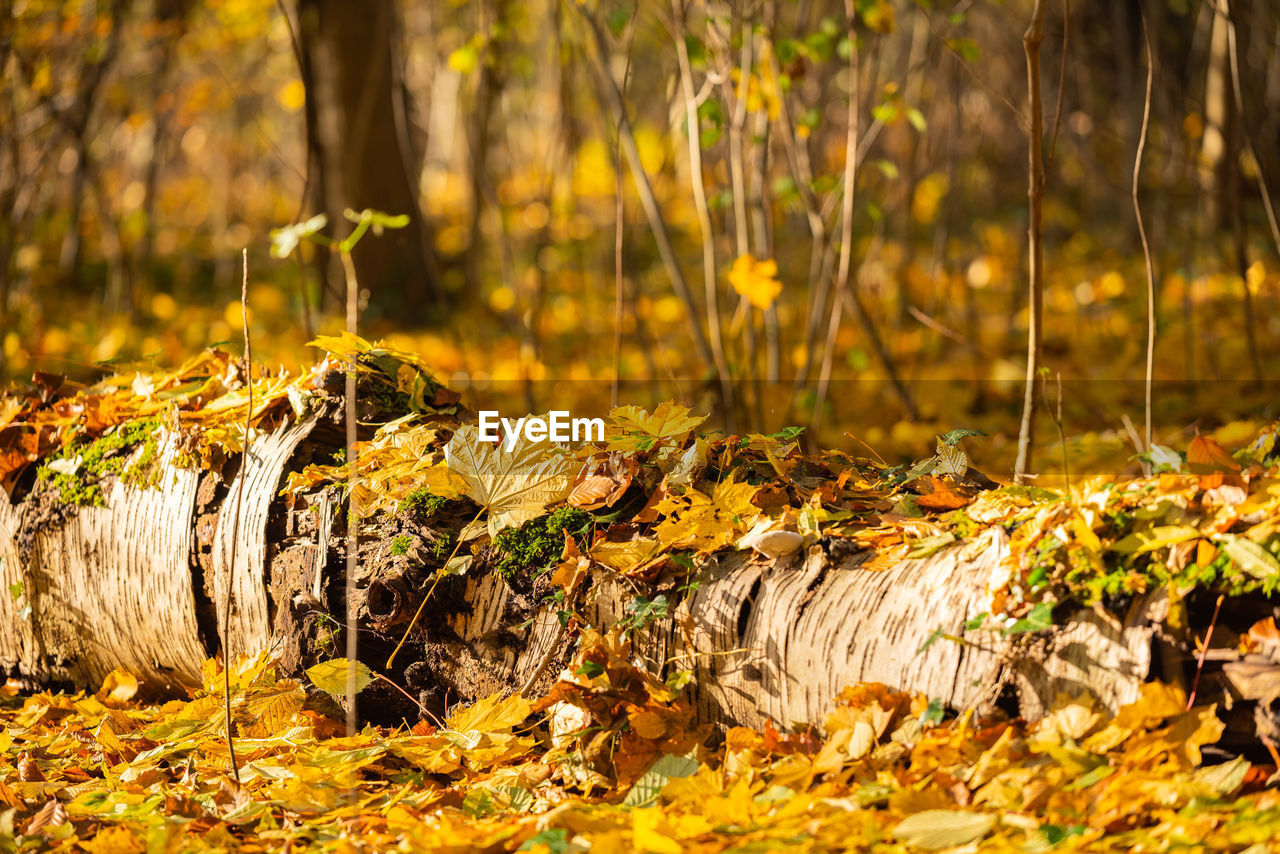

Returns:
0,406,1177,727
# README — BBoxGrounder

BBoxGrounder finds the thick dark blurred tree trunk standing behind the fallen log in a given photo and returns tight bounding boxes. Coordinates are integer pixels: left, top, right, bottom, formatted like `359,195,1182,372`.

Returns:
298,0,440,319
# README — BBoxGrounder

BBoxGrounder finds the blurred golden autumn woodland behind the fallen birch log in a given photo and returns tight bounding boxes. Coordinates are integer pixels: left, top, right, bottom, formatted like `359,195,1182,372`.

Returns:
0,0,1280,472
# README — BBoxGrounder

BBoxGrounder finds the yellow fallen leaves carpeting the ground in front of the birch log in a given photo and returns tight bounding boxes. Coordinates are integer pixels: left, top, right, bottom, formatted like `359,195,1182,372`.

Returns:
0,647,1280,854
